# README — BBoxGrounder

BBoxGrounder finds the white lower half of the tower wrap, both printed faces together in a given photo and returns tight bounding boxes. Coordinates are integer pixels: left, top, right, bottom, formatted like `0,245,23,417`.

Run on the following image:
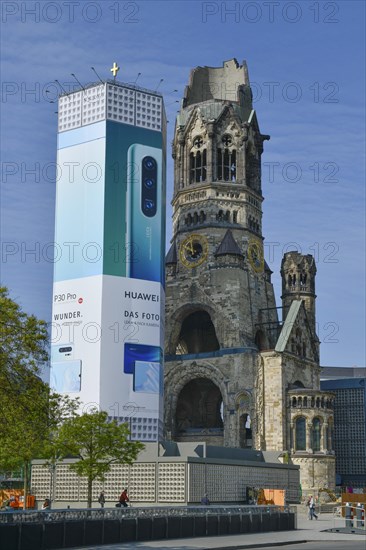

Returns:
51,275,164,440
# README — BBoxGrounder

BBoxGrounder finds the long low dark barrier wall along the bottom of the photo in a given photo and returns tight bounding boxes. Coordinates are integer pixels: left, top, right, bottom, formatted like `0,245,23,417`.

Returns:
0,508,295,550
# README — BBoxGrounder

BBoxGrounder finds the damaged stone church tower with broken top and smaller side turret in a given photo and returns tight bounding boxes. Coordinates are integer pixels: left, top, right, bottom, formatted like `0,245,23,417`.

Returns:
165,59,335,489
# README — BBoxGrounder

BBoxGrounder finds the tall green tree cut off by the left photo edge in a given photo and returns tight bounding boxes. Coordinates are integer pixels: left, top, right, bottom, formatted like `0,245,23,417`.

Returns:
0,287,77,505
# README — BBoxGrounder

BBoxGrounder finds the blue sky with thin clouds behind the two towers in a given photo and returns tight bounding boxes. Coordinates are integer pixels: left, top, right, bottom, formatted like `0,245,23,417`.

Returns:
1,0,365,366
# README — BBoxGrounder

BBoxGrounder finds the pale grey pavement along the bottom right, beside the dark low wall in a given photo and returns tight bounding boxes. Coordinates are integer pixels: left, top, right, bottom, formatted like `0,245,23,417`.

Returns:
58,507,366,550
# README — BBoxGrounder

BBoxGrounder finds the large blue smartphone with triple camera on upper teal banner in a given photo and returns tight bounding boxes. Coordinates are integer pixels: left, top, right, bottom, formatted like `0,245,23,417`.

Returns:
126,143,164,282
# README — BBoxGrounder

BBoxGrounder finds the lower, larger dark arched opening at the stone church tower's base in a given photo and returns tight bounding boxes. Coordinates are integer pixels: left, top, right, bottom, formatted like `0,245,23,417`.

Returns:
175,377,224,443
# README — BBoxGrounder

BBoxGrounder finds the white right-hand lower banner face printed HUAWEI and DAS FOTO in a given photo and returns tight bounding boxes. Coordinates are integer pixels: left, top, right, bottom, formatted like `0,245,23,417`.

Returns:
101,276,164,440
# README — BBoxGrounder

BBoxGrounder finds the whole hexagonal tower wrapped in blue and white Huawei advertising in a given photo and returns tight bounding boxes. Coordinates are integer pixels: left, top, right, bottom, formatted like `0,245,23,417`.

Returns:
50,82,165,441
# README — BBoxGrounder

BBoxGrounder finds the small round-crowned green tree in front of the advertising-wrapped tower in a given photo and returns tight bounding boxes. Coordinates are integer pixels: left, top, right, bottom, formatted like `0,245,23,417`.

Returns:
56,409,144,508
